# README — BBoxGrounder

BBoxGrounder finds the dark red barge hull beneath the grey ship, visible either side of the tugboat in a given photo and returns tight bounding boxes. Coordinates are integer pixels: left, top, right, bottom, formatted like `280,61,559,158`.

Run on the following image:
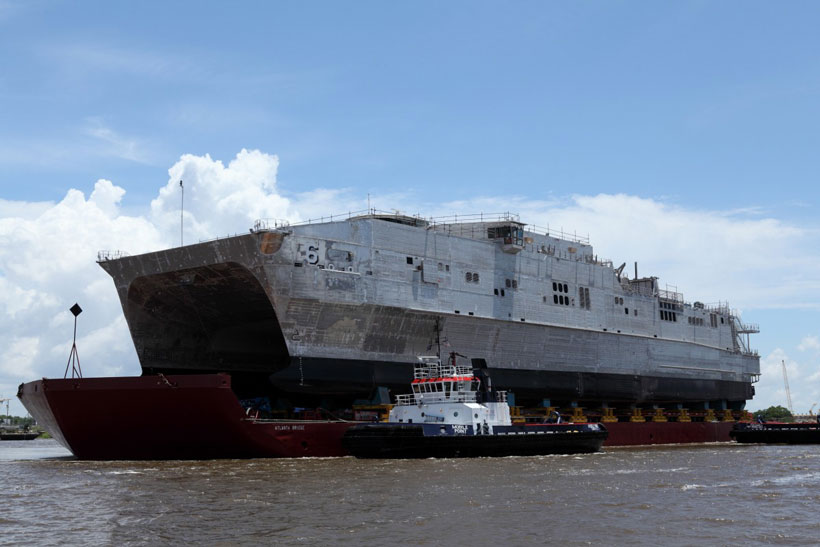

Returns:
17,374,734,460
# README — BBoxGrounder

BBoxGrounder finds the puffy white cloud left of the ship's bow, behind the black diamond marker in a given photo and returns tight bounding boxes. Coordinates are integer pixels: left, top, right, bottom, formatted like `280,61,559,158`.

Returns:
0,179,168,411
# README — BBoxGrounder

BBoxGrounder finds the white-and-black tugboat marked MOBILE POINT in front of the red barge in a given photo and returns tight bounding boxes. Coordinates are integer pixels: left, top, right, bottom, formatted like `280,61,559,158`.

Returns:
342,353,607,458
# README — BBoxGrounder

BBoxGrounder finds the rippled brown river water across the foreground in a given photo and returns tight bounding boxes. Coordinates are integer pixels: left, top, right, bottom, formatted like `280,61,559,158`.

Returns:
0,440,820,546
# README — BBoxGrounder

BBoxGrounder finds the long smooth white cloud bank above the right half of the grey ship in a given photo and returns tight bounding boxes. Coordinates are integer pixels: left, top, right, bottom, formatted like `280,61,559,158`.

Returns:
422,194,820,309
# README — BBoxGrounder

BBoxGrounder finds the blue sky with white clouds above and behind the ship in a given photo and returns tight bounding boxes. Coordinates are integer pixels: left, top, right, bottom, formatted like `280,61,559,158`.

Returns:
0,0,820,416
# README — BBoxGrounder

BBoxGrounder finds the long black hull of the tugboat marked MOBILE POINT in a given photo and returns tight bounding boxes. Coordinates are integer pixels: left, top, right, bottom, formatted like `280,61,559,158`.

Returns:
342,423,607,458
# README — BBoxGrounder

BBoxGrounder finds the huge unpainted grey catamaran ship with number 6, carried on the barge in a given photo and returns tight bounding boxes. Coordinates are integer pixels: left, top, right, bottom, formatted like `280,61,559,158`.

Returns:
99,210,760,410
